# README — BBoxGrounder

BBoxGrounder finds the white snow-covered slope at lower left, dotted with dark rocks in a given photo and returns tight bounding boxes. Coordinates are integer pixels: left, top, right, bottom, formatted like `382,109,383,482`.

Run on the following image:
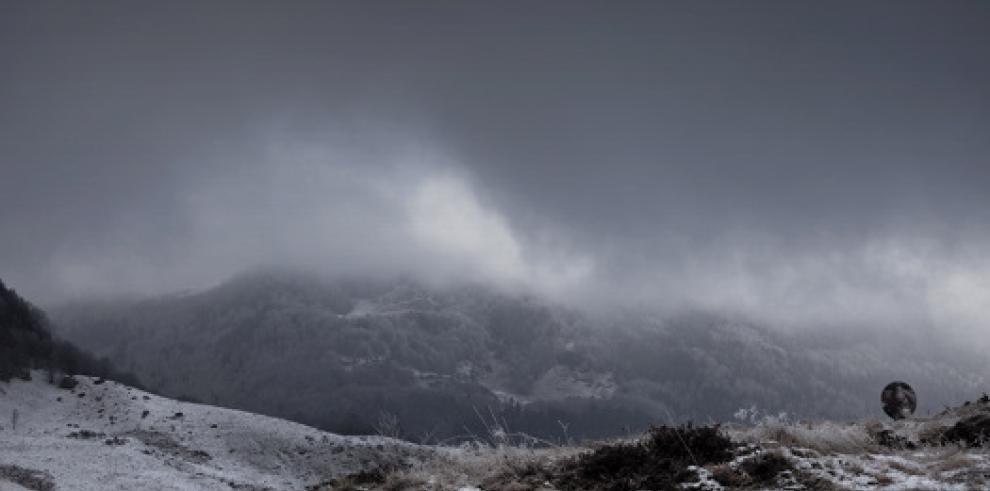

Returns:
0,372,431,491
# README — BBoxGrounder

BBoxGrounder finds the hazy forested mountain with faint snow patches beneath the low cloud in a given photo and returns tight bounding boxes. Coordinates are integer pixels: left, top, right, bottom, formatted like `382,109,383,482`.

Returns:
53,271,990,441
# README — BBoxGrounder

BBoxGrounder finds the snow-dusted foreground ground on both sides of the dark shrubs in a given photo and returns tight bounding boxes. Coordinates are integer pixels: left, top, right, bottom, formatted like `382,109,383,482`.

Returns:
0,372,990,491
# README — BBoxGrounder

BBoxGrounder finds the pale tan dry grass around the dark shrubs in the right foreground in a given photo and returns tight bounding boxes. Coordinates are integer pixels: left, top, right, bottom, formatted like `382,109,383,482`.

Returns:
346,415,990,491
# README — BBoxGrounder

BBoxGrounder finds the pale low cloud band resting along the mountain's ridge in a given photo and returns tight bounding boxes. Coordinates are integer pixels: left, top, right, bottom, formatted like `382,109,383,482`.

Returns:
21,123,990,352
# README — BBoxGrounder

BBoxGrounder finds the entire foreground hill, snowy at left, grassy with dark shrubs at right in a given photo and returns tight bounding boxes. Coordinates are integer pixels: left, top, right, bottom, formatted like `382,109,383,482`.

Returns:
0,372,990,491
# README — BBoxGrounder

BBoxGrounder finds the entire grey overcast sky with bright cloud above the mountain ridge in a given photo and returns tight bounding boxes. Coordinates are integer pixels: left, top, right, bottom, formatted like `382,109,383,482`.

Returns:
0,1,990,332
